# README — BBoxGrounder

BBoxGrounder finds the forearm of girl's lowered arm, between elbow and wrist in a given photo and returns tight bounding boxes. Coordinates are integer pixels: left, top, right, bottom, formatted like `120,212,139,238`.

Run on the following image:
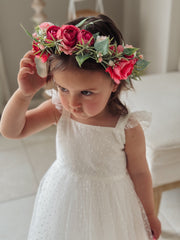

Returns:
131,173,155,216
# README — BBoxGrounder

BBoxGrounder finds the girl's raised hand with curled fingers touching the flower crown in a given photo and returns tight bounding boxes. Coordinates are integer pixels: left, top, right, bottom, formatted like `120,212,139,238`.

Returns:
18,50,46,97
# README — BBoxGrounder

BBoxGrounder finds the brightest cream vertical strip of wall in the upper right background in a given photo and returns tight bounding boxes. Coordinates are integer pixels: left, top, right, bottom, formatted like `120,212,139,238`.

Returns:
140,0,172,73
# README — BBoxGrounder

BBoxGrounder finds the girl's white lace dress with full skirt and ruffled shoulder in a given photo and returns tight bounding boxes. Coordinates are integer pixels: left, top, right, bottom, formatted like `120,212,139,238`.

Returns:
28,91,152,240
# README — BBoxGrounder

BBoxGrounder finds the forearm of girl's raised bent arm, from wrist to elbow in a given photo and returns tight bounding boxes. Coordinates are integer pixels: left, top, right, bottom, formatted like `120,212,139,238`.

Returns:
0,89,33,138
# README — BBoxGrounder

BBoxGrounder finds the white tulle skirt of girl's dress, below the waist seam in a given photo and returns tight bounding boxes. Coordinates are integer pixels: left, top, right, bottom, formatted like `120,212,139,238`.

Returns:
28,160,152,240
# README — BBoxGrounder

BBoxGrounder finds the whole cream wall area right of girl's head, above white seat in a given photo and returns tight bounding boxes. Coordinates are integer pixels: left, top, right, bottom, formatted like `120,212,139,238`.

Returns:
123,0,180,73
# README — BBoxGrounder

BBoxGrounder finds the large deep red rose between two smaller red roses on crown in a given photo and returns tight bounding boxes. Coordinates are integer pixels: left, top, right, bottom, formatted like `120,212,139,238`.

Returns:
57,25,80,55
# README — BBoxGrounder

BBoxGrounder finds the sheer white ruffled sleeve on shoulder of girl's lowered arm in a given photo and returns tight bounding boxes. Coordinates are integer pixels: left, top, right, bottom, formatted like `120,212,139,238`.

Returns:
125,111,152,130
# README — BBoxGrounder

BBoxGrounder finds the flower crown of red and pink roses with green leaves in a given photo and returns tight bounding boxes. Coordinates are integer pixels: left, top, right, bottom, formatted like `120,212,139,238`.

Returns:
24,19,149,84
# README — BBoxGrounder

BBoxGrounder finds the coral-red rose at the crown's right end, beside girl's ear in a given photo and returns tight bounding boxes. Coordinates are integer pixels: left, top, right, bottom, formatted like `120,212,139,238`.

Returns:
106,59,137,84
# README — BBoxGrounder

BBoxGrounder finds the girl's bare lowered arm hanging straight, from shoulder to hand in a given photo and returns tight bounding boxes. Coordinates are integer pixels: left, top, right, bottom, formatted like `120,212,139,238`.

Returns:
125,125,161,239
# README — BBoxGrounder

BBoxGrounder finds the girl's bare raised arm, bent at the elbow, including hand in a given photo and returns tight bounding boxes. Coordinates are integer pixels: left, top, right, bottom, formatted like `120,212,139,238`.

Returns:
0,51,60,138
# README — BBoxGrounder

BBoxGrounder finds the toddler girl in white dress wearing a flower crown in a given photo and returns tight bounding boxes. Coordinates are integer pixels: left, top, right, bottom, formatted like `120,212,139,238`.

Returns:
1,15,161,240
